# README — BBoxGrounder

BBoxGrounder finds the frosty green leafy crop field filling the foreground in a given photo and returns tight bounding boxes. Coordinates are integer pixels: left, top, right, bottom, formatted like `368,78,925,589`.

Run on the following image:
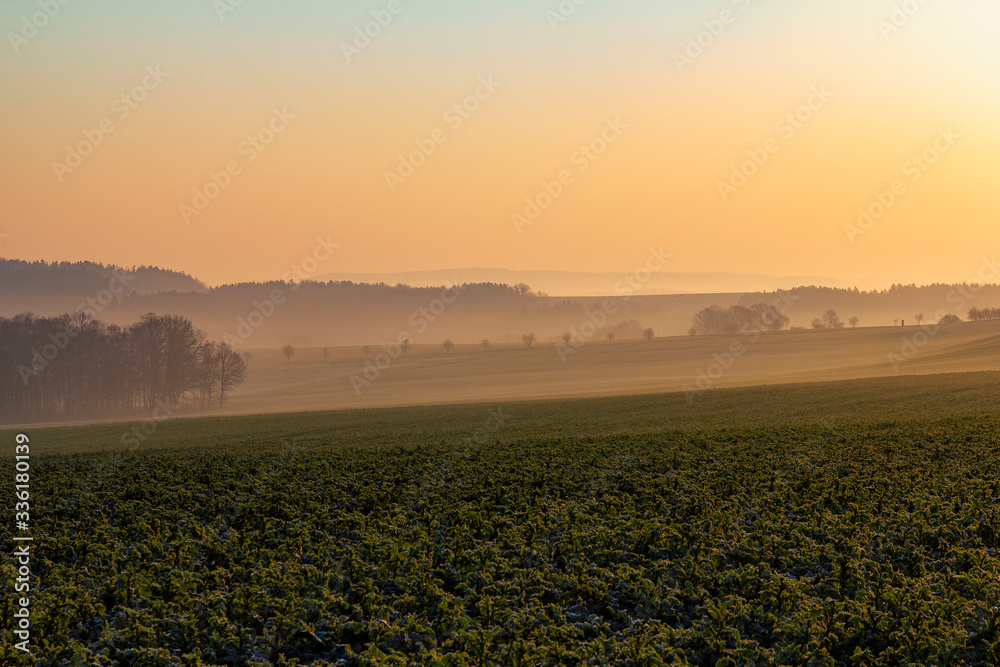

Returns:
0,373,1000,665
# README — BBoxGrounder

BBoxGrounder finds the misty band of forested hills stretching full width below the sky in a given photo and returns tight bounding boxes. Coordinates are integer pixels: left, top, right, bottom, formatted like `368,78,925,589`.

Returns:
0,260,1000,349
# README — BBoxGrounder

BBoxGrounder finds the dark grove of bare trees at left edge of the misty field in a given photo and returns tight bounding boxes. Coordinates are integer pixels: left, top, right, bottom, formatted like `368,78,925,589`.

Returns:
0,313,246,422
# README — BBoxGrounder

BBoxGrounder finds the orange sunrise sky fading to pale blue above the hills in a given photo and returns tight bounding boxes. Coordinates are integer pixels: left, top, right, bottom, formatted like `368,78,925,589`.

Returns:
0,0,1000,289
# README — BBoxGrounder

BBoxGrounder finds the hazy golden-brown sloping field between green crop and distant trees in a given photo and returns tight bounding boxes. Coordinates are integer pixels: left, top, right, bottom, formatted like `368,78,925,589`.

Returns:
213,322,1000,414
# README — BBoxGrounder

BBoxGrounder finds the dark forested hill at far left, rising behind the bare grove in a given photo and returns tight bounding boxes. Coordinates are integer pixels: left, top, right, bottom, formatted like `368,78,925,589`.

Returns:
0,258,208,315
